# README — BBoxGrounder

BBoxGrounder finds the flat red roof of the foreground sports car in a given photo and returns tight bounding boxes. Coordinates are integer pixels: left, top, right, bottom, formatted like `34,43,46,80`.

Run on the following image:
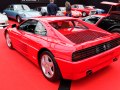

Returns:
33,16,77,22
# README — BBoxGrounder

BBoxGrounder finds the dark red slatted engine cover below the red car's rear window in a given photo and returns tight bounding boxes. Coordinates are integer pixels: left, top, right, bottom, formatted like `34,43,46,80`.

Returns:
65,30,108,44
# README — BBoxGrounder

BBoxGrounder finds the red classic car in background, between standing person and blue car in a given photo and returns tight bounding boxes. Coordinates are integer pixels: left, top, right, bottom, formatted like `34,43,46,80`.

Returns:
72,4,96,17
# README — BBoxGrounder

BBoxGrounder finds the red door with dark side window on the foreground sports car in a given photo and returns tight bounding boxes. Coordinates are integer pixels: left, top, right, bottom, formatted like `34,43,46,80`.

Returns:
14,19,37,56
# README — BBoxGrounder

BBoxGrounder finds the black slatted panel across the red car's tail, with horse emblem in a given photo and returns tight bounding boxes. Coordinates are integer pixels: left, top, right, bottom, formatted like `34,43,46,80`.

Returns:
72,38,120,61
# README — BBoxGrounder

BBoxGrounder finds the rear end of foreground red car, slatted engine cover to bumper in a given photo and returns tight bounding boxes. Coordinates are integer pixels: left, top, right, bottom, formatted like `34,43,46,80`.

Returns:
56,30,120,80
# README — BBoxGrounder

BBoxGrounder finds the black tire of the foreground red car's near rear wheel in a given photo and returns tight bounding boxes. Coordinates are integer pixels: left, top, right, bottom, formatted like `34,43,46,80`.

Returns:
39,51,61,82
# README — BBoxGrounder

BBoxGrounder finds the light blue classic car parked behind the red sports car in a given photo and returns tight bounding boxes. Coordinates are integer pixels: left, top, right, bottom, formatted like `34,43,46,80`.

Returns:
3,4,41,23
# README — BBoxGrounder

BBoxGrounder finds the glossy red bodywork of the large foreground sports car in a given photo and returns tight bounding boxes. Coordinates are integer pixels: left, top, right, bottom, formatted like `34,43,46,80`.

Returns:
5,17,120,80
